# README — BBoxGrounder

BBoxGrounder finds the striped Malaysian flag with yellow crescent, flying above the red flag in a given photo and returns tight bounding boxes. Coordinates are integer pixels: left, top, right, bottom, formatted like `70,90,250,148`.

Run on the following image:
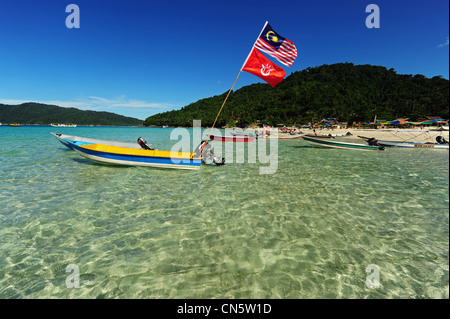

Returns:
255,23,297,66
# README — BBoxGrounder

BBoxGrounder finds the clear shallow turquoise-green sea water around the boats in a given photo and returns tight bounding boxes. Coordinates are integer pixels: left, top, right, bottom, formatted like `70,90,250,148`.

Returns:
0,126,449,299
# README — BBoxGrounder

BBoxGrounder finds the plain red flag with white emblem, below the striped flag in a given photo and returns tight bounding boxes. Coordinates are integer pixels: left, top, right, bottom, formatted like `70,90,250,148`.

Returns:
242,48,286,87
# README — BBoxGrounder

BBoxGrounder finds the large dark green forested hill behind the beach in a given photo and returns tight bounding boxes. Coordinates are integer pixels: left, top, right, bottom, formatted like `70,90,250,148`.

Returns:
144,63,449,127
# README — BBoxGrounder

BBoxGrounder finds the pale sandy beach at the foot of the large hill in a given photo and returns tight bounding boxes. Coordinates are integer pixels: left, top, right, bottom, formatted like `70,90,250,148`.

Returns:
258,129,449,143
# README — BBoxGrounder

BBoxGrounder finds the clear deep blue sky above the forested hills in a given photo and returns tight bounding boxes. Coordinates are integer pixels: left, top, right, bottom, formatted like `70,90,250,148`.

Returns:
0,0,449,121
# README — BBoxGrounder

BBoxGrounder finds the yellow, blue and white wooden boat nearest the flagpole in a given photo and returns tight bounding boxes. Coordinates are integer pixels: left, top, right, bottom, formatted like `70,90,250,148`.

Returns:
64,141,203,170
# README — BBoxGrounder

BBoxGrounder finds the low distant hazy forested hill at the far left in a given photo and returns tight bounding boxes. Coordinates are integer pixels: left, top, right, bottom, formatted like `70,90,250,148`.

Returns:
0,103,142,126
